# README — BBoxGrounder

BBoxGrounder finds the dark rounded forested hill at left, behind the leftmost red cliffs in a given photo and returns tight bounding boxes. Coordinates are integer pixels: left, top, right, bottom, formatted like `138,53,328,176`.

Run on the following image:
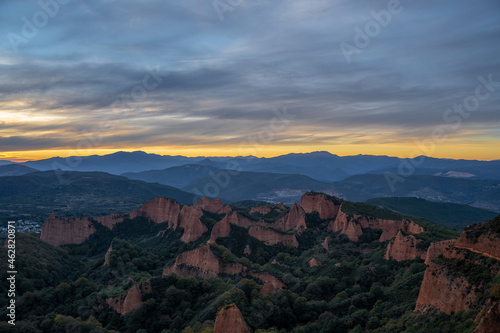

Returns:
0,171,198,221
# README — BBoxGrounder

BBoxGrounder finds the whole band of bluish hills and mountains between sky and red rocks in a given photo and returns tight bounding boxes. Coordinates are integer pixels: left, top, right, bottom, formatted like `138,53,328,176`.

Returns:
0,152,500,219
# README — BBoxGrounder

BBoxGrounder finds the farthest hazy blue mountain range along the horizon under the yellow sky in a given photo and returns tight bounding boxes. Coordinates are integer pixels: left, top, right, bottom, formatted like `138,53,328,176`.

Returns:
0,151,500,182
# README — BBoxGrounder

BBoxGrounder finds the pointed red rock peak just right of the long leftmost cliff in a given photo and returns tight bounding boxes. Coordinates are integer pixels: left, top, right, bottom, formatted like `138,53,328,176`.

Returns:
129,198,180,229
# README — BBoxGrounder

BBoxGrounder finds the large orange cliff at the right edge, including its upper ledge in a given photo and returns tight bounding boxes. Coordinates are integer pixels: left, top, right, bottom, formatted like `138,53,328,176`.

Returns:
415,222,500,316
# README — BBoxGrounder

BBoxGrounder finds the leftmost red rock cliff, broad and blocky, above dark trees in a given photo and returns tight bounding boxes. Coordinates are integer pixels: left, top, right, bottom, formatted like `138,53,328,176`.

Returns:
40,213,96,246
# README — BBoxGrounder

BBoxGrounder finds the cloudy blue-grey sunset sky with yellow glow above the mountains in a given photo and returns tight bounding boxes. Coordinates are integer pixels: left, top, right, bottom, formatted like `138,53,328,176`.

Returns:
0,0,500,161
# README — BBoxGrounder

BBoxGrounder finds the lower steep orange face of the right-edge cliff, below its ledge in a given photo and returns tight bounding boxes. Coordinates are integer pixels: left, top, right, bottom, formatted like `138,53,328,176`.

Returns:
415,262,480,314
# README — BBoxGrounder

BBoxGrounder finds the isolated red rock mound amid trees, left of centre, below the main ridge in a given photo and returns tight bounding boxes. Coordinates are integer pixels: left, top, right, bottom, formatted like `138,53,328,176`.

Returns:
163,245,246,278
